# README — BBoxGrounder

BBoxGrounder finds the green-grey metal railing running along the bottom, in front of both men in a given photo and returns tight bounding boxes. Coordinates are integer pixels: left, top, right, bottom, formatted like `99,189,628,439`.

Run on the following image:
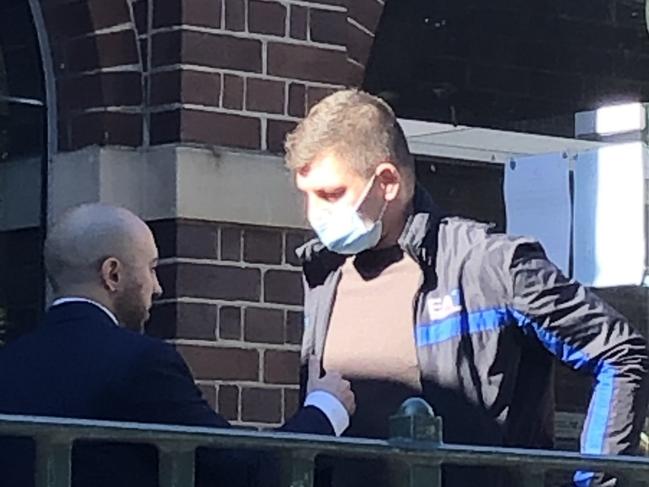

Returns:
0,399,649,487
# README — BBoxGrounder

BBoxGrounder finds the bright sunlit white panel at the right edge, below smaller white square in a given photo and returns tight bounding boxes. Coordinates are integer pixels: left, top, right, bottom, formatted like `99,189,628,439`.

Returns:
573,142,646,287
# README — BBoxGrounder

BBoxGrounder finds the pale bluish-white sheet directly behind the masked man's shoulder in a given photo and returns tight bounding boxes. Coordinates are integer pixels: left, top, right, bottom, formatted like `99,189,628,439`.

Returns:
504,153,571,275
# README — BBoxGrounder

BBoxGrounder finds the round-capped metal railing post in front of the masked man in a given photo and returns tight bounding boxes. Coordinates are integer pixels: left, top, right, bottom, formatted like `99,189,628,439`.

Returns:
389,397,442,487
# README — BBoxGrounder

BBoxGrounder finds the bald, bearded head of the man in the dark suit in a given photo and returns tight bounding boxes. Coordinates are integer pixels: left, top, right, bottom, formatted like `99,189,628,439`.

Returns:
45,204,162,331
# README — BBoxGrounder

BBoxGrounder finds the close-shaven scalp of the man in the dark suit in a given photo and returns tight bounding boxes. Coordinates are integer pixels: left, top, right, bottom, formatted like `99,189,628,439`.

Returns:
45,204,150,292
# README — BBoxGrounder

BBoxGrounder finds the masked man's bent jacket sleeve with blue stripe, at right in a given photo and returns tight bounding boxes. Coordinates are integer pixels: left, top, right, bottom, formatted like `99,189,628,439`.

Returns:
509,243,649,484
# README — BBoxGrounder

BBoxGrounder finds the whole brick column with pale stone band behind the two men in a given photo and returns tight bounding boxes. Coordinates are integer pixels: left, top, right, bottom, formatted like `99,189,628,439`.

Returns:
33,0,383,427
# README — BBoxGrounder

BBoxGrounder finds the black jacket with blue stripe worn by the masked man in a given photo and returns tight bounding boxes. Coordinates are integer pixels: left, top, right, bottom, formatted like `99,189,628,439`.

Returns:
300,189,649,485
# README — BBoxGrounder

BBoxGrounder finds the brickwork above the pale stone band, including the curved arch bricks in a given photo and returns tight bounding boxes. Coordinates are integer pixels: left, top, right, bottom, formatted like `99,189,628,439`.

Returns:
42,0,383,152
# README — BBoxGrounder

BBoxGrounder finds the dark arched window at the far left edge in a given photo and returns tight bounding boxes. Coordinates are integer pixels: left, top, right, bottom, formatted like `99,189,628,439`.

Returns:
0,0,46,341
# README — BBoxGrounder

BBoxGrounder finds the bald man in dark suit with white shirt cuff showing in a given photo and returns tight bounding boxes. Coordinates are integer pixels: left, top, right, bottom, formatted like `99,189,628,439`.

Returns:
0,204,355,487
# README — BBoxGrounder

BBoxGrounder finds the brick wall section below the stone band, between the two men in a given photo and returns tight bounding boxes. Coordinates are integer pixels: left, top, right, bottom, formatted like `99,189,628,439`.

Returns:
148,220,305,426
